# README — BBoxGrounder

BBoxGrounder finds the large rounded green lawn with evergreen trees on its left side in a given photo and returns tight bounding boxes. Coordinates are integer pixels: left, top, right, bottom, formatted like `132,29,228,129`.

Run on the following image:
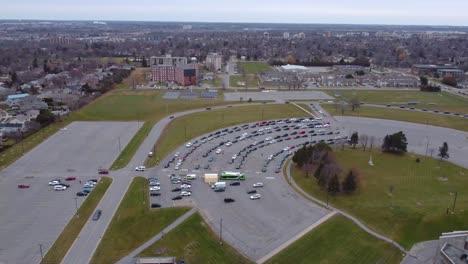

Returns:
291,148,468,249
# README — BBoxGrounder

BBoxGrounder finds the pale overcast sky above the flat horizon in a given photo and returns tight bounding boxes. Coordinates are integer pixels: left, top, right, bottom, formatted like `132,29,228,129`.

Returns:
0,0,468,26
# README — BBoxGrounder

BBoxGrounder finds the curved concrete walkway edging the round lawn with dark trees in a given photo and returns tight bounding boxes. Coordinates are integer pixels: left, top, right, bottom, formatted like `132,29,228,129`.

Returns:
286,163,409,254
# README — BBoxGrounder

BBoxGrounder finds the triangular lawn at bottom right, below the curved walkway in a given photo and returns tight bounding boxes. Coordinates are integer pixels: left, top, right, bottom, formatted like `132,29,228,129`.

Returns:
266,215,402,264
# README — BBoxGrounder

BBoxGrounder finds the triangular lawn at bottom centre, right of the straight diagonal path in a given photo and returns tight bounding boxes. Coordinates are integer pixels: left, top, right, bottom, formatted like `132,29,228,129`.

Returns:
140,212,252,263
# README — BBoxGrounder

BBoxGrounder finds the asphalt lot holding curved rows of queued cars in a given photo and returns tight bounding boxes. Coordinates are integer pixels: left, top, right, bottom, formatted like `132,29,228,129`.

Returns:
144,117,341,260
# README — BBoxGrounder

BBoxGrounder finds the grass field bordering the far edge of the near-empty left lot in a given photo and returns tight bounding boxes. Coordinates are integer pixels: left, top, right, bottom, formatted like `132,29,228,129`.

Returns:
0,90,234,168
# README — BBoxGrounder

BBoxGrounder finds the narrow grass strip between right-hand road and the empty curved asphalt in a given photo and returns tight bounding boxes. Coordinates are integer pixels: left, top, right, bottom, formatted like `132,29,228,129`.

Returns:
321,104,468,131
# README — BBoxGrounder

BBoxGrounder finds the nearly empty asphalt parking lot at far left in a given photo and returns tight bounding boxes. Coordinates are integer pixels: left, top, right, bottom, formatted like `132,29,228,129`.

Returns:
0,122,139,263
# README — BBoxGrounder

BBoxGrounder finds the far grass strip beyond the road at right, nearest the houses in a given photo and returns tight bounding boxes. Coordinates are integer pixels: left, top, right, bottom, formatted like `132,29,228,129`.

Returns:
324,90,468,114
